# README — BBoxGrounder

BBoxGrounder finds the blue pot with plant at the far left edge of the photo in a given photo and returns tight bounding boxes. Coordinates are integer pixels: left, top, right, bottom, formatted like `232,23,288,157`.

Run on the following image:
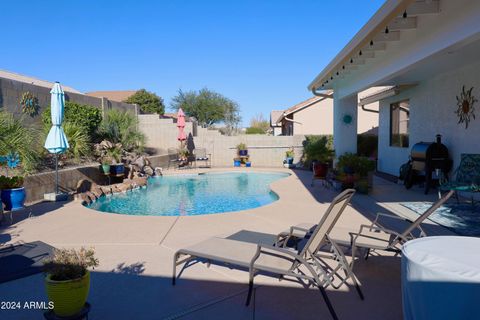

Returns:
0,176,26,211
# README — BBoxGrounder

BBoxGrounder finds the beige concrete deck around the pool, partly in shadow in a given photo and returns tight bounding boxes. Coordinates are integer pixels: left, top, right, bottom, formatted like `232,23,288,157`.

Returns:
0,168,456,320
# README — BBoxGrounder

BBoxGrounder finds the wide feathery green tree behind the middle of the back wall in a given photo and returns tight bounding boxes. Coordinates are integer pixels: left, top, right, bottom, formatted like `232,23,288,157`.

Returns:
171,88,241,132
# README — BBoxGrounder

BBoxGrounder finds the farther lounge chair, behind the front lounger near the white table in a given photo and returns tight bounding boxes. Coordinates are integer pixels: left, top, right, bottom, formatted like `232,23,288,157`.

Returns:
350,190,454,268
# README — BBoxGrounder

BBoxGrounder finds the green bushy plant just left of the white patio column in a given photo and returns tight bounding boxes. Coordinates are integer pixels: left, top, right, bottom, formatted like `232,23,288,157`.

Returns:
303,135,335,166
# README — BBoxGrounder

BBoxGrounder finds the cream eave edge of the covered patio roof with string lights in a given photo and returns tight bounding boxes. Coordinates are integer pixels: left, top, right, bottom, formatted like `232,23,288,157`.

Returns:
308,0,438,92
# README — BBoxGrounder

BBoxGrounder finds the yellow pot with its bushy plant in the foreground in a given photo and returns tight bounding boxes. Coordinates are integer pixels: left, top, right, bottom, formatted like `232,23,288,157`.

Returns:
44,248,98,317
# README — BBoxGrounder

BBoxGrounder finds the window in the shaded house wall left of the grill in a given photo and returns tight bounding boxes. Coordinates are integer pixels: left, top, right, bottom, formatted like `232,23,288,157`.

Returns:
390,100,410,148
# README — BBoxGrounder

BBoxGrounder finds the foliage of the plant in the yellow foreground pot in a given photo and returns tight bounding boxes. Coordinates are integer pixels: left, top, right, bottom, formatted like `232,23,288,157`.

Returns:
44,248,98,281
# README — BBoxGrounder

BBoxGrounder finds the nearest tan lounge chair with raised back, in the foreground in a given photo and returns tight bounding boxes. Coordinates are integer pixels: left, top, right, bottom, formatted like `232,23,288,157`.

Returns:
172,189,363,319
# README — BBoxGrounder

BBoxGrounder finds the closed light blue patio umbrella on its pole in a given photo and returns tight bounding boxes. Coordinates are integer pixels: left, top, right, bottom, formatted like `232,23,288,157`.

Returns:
45,82,69,194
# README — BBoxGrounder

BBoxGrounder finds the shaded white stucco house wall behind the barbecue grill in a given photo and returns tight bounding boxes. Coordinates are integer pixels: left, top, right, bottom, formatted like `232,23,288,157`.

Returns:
378,58,480,176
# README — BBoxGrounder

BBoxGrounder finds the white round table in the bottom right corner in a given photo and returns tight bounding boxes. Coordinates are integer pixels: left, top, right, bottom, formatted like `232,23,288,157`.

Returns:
402,236,480,320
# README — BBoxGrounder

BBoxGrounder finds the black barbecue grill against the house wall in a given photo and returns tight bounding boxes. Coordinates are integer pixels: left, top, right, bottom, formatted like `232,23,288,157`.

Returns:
406,134,452,194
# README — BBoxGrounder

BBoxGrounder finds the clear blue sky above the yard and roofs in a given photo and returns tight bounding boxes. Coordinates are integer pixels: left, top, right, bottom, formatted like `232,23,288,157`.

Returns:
0,0,383,125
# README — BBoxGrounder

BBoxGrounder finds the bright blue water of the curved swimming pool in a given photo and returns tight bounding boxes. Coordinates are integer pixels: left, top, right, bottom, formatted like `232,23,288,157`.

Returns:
88,172,288,216
